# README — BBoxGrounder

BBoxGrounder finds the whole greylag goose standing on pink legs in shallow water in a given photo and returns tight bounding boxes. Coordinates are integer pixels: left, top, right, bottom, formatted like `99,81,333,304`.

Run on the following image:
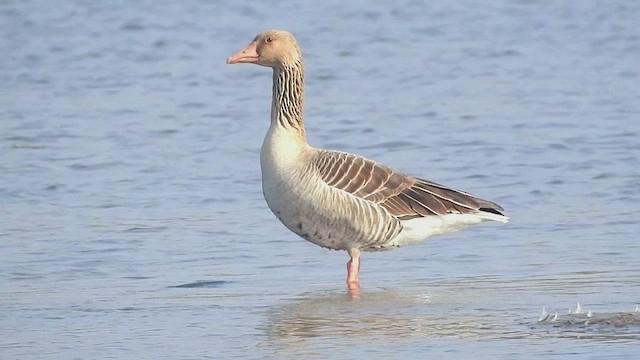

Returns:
227,30,508,290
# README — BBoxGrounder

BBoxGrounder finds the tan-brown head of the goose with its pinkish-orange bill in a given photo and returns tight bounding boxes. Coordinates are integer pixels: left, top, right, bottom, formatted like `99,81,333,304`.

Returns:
227,30,302,69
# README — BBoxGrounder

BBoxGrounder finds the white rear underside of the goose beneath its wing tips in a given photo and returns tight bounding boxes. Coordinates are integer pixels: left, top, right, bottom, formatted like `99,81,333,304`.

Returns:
385,213,509,247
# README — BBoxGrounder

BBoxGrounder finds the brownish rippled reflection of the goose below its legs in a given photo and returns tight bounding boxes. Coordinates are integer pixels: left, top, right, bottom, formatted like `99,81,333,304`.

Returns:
263,289,492,350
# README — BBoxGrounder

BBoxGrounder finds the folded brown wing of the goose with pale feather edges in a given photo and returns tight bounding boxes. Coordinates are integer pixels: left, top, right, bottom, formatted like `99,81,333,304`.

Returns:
314,150,507,222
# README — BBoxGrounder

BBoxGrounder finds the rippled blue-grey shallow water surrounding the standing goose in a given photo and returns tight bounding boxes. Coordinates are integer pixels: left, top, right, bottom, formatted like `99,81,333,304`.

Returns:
0,0,640,359
